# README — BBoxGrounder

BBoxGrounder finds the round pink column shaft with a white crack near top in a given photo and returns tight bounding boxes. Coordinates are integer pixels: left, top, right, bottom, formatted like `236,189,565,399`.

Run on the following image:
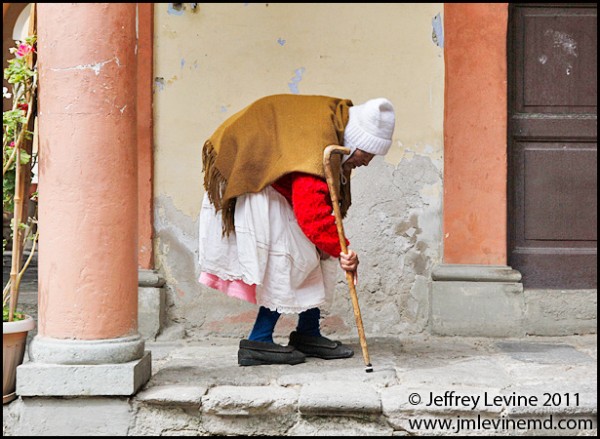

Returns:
38,3,139,340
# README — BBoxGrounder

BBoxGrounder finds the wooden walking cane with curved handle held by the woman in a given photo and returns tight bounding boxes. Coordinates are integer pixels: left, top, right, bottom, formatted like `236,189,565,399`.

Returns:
323,145,373,372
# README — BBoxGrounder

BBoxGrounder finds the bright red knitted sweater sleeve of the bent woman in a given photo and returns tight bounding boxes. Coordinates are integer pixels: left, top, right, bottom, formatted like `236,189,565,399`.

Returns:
272,172,349,258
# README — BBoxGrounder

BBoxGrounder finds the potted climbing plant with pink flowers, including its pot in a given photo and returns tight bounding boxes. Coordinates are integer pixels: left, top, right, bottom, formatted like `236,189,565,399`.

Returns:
2,22,38,404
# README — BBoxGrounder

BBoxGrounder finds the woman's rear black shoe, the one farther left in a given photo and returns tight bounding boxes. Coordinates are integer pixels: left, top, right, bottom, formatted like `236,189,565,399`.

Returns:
238,339,306,366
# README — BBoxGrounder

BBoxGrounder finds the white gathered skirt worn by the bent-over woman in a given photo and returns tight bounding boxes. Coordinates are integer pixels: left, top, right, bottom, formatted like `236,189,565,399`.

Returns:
199,186,338,313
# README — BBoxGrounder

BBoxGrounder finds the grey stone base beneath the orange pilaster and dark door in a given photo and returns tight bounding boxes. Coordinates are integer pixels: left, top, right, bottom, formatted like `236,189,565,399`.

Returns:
430,264,598,337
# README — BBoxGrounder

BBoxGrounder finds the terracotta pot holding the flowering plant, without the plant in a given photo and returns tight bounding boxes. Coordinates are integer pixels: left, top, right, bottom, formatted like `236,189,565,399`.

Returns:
2,315,35,404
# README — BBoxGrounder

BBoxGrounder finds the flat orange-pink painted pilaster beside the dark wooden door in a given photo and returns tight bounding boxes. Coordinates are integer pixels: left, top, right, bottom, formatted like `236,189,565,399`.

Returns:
444,3,508,265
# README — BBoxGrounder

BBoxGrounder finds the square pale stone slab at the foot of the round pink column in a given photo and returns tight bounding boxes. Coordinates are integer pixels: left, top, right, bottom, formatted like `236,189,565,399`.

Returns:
16,351,152,396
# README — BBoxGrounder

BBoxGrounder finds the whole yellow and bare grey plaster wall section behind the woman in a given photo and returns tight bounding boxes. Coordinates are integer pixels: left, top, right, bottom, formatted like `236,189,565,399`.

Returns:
154,3,444,341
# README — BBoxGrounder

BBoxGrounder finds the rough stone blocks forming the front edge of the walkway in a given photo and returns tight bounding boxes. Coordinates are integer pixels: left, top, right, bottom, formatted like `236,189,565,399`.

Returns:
129,381,597,436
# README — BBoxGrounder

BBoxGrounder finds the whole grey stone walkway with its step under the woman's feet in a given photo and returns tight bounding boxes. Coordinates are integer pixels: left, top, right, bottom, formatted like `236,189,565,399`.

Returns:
4,335,597,436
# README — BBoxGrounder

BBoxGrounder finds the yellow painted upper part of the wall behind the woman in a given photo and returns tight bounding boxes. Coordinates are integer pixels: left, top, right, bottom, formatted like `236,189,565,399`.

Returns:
154,3,444,217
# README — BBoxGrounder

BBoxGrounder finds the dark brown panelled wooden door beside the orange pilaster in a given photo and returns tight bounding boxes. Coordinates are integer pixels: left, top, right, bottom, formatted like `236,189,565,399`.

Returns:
508,3,597,289
